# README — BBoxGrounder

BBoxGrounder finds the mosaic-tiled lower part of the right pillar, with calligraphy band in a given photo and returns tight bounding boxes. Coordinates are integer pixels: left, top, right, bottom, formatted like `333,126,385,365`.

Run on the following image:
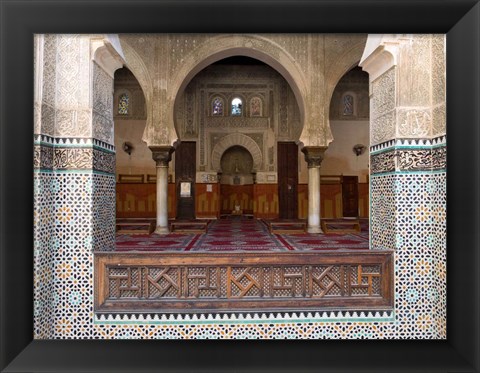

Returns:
370,137,446,338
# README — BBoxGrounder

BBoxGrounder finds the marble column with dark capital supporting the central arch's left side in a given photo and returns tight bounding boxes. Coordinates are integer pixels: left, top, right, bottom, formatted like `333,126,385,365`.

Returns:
150,145,175,234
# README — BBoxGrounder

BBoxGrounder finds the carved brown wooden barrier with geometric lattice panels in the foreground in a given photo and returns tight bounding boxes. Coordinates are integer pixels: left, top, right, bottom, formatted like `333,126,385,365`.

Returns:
95,251,393,313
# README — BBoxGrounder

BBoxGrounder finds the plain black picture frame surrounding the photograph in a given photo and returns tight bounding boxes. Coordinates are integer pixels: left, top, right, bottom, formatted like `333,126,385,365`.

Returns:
0,0,480,372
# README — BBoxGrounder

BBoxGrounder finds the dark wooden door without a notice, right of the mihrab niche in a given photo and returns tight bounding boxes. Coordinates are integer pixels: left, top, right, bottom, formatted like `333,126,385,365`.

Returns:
277,142,298,219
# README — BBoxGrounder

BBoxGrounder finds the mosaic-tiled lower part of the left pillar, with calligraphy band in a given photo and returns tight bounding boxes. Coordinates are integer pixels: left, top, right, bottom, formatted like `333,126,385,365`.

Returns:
34,135,115,338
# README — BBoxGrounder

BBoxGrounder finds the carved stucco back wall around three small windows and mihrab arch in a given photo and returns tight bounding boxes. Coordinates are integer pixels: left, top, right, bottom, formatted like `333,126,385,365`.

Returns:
176,64,302,180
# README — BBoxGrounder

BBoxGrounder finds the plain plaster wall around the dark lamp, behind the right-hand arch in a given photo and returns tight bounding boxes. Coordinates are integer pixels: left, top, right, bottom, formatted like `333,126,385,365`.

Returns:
320,120,369,183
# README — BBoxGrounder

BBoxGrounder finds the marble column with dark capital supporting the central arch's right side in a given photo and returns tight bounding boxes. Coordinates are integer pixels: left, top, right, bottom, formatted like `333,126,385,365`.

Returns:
302,146,327,233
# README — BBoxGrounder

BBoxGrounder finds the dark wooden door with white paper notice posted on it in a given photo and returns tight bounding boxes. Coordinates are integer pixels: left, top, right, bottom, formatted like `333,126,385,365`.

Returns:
175,141,197,219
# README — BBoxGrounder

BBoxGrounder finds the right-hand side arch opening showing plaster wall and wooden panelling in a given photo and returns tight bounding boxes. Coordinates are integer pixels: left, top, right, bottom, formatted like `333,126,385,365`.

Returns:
320,65,370,221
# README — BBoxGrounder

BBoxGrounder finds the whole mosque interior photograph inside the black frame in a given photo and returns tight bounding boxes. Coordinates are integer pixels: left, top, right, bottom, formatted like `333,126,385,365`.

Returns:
33,33,447,339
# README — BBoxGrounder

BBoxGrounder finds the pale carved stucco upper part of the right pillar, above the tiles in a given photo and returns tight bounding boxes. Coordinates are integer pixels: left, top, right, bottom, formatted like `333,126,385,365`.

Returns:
362,35,446,144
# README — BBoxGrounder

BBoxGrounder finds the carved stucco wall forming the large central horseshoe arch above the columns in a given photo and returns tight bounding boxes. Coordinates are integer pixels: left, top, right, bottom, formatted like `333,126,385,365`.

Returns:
120,34,366,146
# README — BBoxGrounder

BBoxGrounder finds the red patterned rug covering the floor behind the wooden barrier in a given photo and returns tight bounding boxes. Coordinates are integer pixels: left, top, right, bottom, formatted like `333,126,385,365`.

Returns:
116,217,369,252
